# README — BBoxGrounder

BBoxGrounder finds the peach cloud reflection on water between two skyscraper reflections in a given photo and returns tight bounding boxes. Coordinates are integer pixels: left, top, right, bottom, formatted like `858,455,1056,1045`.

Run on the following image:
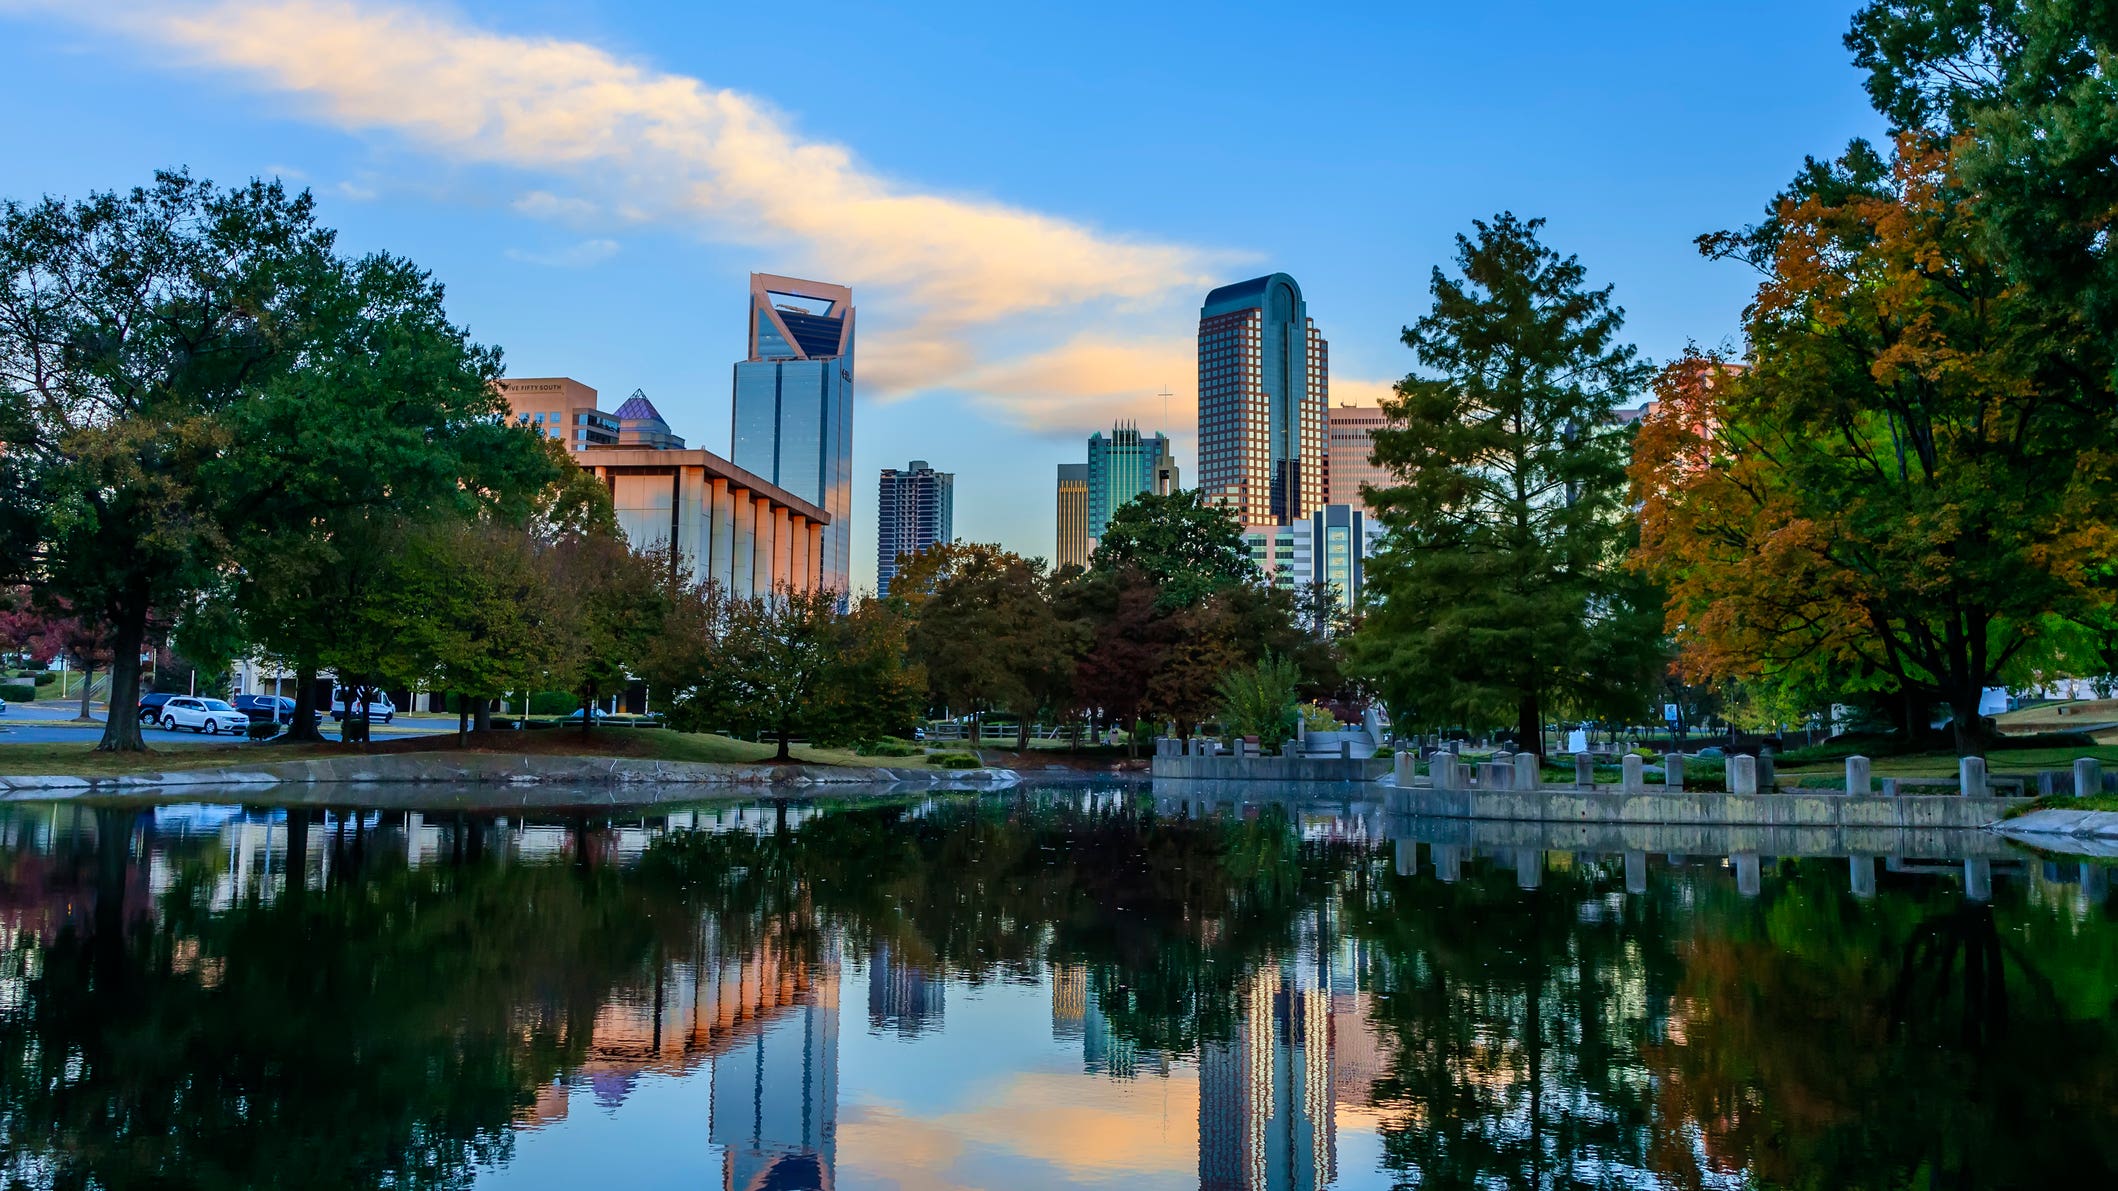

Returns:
839,1068,1199,1191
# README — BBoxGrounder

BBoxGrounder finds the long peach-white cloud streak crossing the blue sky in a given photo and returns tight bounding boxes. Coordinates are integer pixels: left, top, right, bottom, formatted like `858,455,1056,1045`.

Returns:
0,0,1237,426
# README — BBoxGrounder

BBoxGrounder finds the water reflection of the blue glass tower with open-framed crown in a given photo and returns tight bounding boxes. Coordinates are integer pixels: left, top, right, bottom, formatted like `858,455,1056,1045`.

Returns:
707,936,839,1191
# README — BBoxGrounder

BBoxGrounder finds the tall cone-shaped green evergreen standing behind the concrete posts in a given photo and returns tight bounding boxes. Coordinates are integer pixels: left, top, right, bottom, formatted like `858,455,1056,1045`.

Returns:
1353,214,1654,752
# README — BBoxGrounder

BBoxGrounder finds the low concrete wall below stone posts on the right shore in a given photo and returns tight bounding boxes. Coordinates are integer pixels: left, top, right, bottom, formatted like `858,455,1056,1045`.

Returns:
1387,788,2021,829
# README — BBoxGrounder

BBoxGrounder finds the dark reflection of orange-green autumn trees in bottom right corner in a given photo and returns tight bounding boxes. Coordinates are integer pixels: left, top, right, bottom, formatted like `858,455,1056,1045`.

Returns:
1646,863,2118,1187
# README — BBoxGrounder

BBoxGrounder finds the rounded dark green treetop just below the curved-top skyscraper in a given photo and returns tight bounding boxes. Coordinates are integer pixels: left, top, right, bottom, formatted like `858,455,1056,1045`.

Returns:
1089,490,1258,610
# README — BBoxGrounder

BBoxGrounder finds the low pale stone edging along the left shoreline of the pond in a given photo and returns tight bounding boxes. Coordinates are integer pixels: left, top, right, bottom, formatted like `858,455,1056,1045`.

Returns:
0,752,1017,799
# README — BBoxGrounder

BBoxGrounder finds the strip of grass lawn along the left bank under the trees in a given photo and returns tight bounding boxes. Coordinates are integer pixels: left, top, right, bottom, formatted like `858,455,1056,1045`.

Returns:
0,727,928,778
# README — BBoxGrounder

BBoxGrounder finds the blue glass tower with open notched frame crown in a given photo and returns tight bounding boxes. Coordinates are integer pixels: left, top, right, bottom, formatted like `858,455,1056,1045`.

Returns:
729,273,854,591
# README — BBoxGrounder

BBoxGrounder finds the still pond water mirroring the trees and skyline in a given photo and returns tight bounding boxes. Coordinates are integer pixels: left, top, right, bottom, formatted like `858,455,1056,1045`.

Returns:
0,788,2118,1191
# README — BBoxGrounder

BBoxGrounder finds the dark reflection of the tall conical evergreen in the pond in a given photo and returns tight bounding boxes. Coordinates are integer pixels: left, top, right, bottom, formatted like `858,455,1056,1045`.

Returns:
1347,851,1675,1189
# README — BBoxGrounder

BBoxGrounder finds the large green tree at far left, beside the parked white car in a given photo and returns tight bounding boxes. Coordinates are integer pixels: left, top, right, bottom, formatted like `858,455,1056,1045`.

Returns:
0,174,333,750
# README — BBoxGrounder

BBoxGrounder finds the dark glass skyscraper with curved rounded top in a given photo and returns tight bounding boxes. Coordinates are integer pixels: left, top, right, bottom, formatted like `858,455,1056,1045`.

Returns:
1199,273,1330,526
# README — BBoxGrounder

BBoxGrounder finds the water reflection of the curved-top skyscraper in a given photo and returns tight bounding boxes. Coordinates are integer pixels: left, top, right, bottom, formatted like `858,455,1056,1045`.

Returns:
1199,968,1336,1191
